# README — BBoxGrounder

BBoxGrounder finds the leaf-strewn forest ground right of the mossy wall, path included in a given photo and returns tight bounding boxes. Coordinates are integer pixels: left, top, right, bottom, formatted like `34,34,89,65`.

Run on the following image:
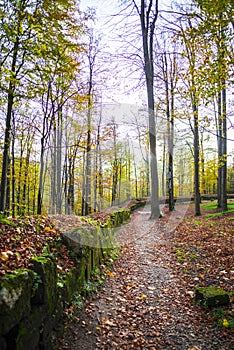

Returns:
55,204,234,350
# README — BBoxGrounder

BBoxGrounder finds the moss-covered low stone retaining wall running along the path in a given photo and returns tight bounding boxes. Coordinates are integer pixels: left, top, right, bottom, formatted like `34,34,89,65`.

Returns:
0,203,145,350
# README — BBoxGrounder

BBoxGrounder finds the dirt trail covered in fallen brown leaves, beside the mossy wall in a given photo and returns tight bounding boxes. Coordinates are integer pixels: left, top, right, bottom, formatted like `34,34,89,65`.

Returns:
57,207,234,350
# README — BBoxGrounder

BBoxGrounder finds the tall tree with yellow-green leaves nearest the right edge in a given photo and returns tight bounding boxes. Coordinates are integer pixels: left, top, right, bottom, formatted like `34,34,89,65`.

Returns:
196,0,234,211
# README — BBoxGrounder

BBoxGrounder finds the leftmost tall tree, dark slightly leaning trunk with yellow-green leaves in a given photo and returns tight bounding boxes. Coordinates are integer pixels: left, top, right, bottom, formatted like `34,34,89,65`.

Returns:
0,0,32,212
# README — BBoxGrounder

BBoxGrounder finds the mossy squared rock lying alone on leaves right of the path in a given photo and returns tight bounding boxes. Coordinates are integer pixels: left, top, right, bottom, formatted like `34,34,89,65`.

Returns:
195,286,230,307
